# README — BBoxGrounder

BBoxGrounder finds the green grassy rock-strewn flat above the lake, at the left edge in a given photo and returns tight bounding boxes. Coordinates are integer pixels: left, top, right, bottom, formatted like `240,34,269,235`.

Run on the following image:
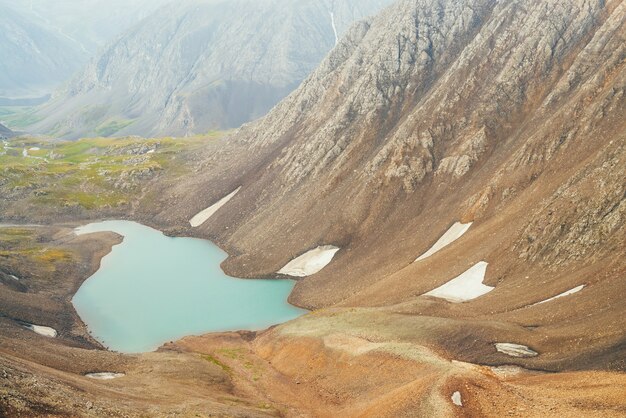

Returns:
0,132,220,210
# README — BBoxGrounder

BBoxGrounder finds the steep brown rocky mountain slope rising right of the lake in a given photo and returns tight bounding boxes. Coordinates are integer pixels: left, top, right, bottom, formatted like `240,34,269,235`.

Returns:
146,0,626,370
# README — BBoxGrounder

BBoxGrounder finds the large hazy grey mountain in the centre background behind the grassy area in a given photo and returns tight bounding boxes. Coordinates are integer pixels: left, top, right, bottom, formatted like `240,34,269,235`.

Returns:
31,0,391,138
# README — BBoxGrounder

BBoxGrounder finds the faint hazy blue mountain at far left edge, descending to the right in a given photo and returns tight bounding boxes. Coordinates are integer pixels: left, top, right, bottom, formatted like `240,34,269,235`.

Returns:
0,2,86,97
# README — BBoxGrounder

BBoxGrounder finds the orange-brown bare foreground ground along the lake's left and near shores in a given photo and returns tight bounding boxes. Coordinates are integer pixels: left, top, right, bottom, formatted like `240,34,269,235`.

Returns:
0,225,626,417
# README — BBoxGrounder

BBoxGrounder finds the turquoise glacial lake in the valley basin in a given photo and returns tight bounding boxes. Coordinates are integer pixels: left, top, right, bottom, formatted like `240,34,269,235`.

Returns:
72,221,307,353
